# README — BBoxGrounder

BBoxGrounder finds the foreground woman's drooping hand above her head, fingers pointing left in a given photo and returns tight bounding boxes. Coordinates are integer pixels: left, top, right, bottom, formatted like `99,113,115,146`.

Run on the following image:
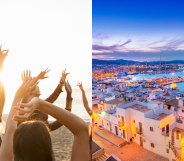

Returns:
13,97,41,122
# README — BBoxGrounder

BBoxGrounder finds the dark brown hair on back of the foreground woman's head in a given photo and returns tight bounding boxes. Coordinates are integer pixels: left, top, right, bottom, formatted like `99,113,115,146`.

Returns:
13,121,53,161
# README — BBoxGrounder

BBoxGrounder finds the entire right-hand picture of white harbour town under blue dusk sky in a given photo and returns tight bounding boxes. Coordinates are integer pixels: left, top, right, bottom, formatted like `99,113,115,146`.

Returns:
92,0,184,161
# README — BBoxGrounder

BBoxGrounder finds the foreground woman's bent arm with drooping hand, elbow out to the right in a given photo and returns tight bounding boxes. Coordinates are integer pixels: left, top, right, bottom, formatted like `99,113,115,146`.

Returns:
15,98,89,161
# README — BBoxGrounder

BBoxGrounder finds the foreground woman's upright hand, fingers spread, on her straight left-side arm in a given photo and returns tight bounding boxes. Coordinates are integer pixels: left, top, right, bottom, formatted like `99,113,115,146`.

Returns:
15,77,39,99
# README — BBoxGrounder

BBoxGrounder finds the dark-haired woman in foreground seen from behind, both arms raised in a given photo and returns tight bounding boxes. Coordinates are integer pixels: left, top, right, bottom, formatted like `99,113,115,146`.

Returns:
0,78,89,161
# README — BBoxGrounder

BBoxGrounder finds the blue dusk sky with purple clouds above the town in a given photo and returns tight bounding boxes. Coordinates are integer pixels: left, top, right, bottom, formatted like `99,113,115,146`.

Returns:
92,0,184,61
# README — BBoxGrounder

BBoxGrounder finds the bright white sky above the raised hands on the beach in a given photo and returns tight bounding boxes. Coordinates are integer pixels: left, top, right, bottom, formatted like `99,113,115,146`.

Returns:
0,0,92,114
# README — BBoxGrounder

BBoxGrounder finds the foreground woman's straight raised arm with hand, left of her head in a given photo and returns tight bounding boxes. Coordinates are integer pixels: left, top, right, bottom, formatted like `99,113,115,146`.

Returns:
0,78,38,161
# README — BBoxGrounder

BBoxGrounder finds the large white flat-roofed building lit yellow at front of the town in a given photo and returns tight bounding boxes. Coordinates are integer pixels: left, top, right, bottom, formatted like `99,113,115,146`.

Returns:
93,101,184,161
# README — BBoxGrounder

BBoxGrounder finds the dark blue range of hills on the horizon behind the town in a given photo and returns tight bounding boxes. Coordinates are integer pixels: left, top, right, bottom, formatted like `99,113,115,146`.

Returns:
92,59,184,65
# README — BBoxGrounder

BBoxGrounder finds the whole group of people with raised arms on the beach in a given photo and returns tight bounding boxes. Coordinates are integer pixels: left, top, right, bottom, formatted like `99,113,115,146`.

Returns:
0,46,92,161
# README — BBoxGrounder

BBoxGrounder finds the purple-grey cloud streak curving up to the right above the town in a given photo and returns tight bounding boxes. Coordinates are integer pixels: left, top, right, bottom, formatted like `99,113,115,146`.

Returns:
92,39,131,51
